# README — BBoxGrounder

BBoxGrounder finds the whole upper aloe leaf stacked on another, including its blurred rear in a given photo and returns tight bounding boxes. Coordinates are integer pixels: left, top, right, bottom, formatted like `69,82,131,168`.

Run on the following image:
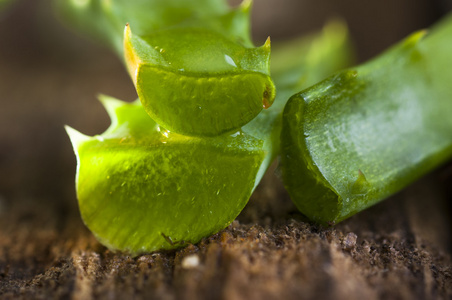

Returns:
56,0,275,136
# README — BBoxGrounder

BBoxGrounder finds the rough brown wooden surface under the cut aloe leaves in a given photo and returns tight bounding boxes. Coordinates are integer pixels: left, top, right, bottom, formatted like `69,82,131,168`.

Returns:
0,171,452,299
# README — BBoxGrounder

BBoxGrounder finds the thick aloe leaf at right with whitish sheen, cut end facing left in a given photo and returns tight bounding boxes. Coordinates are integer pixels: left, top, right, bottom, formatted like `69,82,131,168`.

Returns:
281,14,452,224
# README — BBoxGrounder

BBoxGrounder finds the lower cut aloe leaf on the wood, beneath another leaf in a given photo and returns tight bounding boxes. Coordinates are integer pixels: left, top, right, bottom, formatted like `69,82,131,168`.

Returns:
67,25,354,255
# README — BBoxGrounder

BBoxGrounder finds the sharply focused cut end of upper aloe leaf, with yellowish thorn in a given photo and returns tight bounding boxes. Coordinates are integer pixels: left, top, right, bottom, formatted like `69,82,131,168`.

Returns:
124,26,275,136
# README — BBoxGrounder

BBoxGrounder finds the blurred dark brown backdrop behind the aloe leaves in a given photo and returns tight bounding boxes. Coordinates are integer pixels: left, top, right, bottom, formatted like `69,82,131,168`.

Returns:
0,0,452,220
